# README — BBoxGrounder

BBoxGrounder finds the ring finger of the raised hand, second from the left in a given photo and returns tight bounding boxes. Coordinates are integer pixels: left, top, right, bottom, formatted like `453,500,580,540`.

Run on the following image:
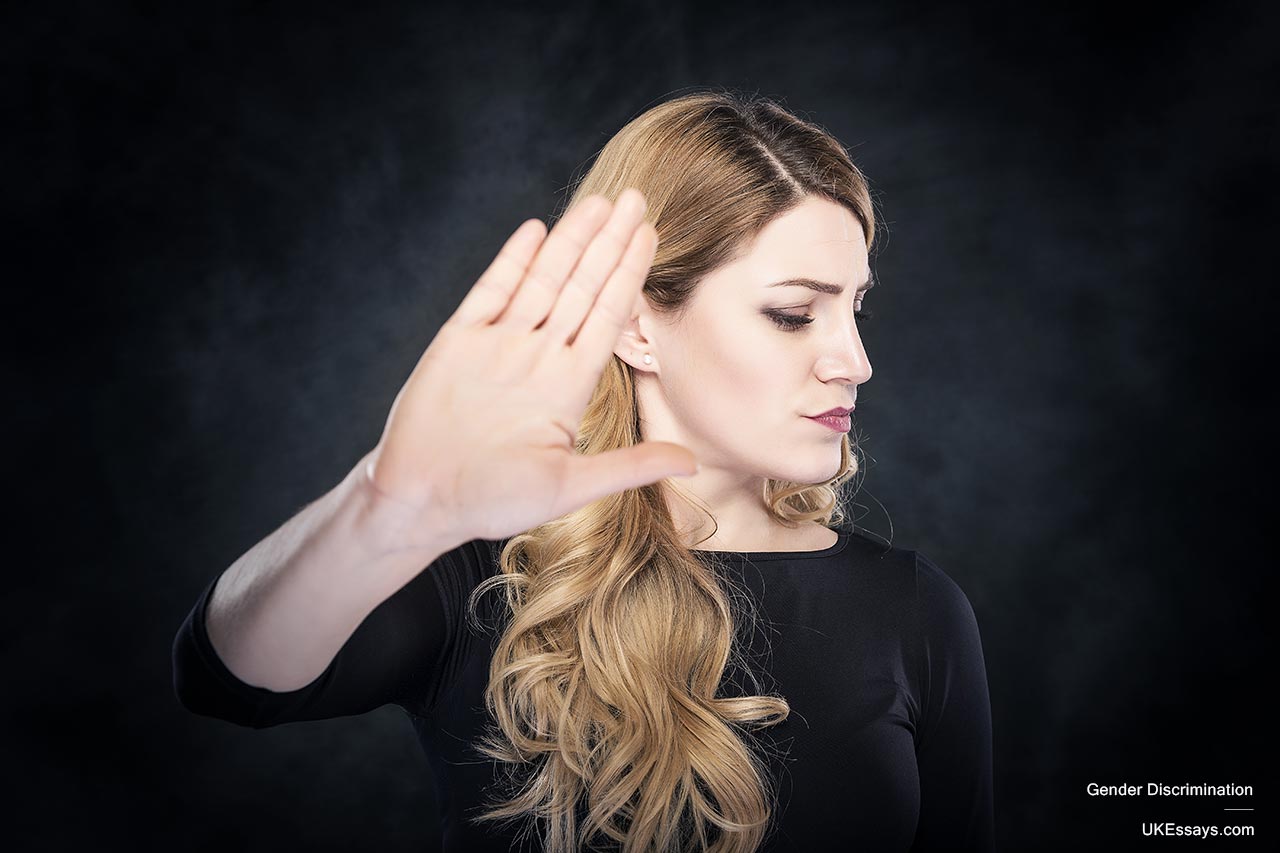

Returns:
498,195,613,332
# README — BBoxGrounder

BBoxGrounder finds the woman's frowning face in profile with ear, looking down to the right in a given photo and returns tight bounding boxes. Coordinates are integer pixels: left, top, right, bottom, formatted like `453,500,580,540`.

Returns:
618,197,872,483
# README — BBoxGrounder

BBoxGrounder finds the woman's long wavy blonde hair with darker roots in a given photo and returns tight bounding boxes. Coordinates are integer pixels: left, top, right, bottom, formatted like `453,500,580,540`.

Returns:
468,91,874,853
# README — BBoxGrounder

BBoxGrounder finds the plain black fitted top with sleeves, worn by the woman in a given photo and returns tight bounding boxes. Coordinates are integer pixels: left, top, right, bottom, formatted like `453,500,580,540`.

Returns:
173,529,995,853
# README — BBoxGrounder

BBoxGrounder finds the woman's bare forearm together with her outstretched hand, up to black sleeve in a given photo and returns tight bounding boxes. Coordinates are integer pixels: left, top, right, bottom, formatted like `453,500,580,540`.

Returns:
174,188,695,719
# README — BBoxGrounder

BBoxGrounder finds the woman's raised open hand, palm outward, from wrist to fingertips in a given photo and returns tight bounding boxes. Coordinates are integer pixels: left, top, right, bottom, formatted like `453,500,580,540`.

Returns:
365,188,696,547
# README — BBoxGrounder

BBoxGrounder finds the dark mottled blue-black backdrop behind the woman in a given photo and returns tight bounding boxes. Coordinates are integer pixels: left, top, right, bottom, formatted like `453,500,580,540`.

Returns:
0,1,1280,850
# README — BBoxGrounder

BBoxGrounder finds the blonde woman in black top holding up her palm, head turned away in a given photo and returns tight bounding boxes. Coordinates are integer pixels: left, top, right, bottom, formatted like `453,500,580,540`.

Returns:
174,92,993,852
